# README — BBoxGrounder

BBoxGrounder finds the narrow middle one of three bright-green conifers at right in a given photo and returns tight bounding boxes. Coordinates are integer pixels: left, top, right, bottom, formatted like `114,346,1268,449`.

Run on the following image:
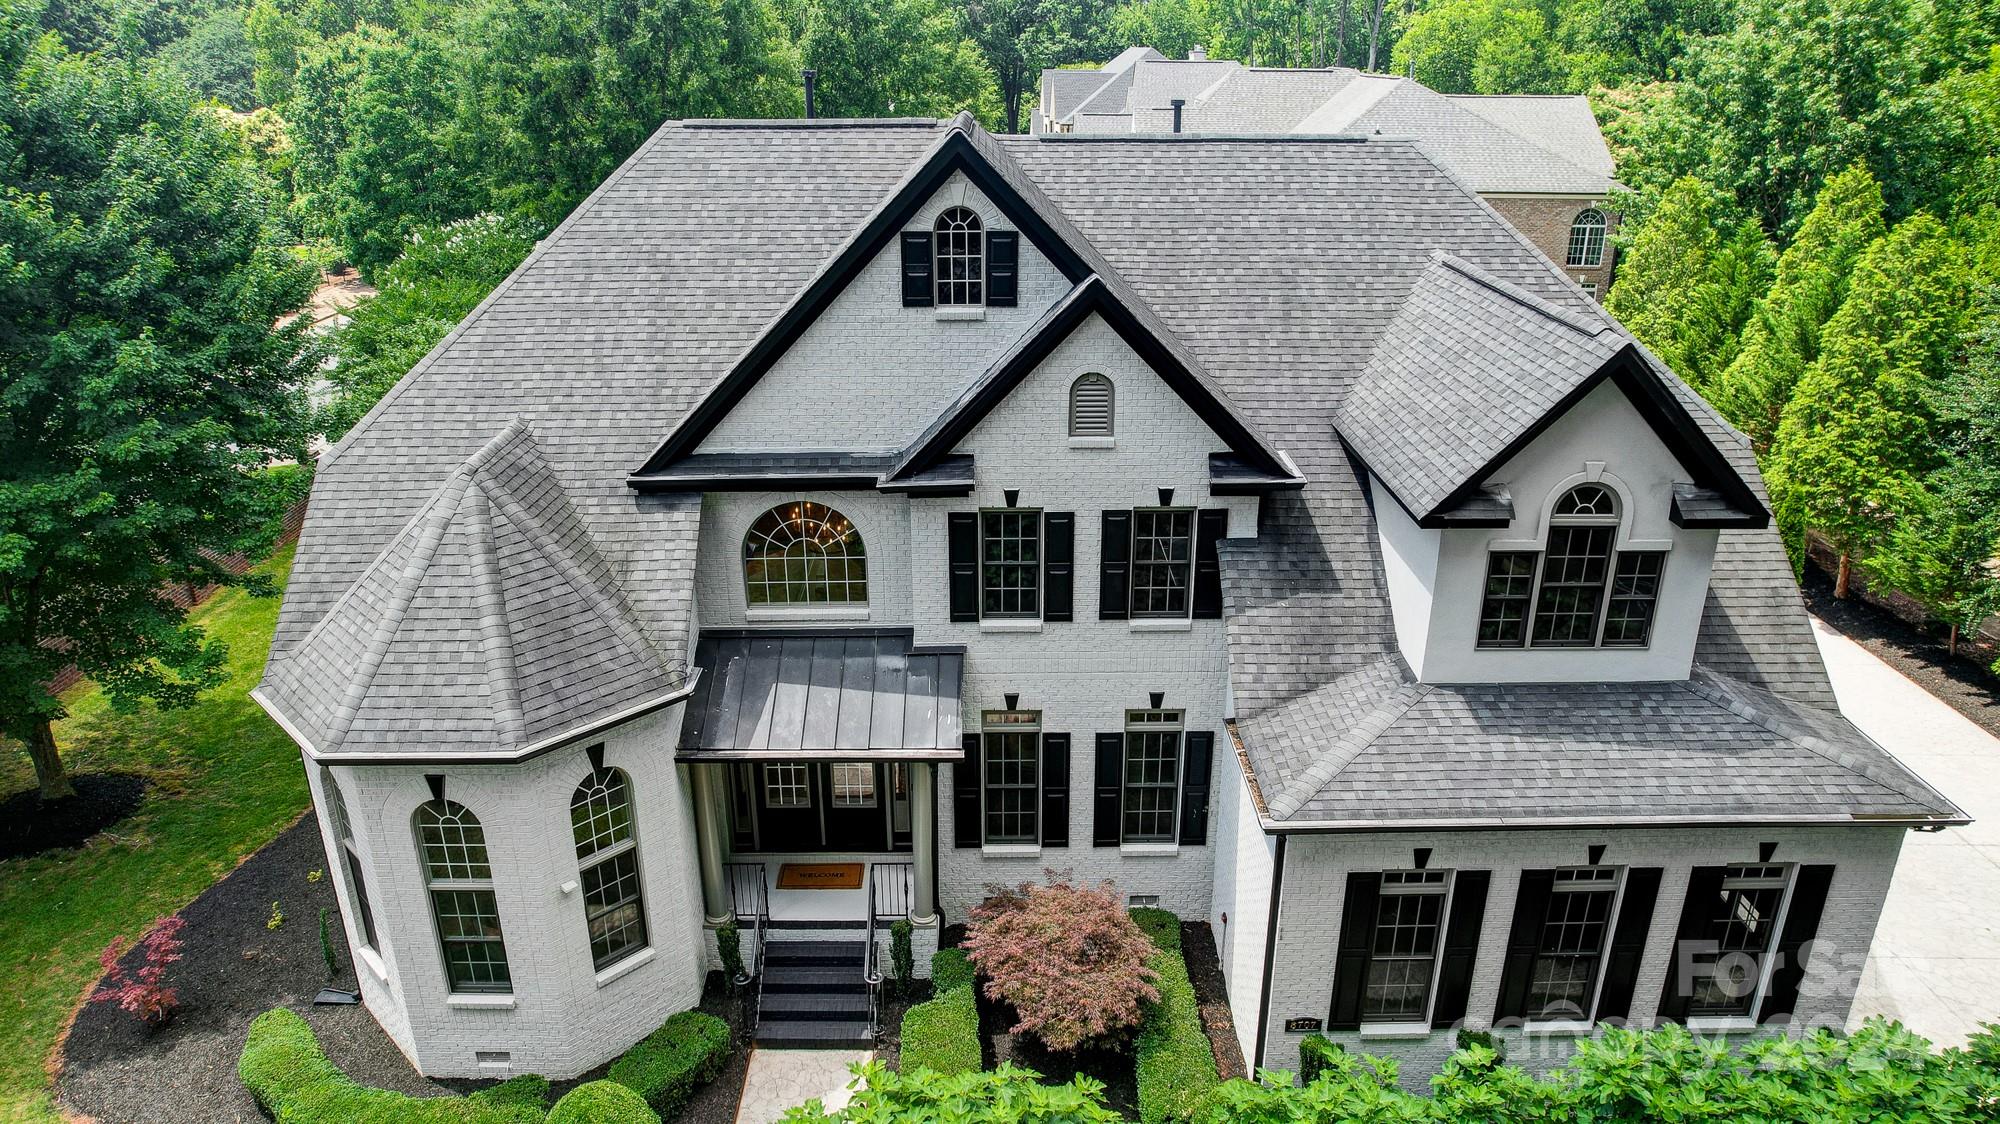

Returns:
1706,166,1888,450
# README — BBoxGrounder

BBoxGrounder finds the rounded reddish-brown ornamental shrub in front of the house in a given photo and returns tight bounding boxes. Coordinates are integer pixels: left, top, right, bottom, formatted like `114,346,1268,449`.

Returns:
964,882,1160,1050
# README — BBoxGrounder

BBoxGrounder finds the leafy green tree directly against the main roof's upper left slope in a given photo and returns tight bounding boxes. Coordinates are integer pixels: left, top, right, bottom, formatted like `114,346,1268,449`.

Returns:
316,214,544,440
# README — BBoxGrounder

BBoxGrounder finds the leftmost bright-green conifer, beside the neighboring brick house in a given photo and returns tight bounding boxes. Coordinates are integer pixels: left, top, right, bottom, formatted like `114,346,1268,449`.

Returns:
1604,176,1772,390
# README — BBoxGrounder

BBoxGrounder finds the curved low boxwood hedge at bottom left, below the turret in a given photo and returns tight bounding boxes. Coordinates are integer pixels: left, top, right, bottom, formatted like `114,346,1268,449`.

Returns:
236,1008,548,1124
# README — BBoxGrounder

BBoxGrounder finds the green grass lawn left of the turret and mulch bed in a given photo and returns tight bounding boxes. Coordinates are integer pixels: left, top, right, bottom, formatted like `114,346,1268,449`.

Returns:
0,548,308,1124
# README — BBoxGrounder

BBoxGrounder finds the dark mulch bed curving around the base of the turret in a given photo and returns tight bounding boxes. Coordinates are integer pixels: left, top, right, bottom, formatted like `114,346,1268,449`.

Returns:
56,816,750,1124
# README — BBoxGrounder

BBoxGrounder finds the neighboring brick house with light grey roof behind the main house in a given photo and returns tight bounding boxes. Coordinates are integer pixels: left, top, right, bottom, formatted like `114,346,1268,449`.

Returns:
1030,46,1618,300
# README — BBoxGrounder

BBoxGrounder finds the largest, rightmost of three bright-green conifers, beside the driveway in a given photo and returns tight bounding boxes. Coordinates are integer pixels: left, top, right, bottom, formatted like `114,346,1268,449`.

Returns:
1768,214,1966,596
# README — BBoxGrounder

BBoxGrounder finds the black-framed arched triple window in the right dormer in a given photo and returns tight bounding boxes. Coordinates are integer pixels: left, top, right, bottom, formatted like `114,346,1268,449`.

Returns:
1478,484,1666,648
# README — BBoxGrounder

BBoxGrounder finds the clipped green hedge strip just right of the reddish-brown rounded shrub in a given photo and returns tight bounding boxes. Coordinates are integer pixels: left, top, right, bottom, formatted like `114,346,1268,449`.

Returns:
1132,910,1222,1124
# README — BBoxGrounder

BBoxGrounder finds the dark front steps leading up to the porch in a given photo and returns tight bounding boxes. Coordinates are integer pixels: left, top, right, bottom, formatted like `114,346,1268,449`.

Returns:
756,934,874,1050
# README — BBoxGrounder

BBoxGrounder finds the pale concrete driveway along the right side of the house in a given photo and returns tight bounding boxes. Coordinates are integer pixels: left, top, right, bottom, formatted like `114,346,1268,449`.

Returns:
1812,620,2000,1046
